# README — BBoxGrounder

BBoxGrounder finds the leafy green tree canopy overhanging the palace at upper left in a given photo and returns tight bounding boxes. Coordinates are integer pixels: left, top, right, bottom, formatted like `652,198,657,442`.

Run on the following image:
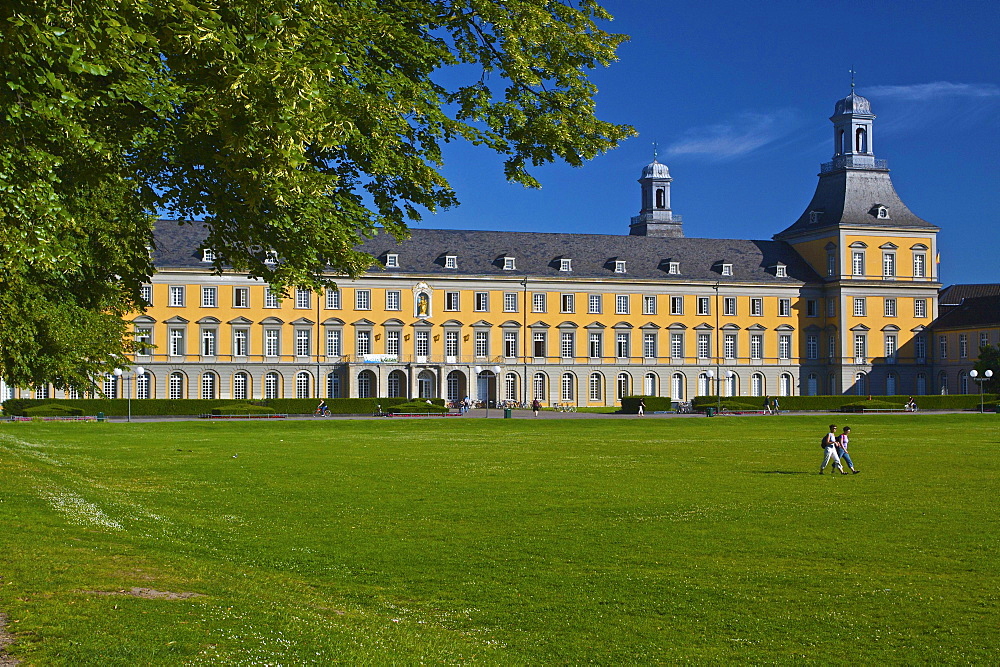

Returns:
0,0,632,387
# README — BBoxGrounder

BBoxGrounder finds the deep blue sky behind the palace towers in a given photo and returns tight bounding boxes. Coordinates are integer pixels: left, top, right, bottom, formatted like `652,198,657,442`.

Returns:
426,0,1000,284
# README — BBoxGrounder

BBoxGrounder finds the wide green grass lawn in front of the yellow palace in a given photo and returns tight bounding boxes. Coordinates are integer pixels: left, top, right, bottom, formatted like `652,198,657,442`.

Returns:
0,414,1000,665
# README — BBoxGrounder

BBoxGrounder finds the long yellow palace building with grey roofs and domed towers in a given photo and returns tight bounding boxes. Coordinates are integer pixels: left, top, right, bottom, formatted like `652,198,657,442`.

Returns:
1,92,941,406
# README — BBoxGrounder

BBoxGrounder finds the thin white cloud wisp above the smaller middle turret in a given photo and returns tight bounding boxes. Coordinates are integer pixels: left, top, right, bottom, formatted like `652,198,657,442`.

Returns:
666,109,795,160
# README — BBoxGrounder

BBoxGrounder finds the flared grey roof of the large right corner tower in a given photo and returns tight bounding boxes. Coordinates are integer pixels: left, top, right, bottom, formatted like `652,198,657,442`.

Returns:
774,167,939,239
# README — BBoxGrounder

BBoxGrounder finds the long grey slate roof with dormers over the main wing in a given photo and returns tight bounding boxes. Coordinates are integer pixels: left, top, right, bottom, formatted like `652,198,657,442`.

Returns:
153,220,822,285
